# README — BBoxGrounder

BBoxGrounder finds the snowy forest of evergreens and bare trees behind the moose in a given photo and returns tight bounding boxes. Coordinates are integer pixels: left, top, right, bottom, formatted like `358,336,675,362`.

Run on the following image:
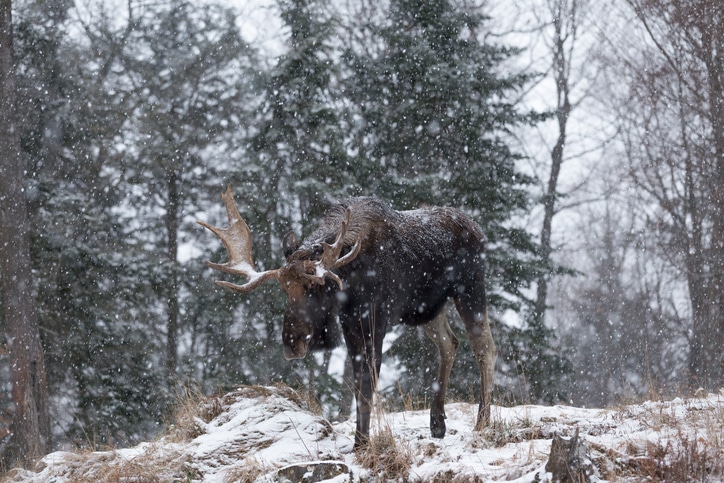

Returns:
0,0,724,463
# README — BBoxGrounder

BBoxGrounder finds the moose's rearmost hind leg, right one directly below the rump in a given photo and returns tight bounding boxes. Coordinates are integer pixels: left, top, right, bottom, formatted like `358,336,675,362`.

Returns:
455,292,498,431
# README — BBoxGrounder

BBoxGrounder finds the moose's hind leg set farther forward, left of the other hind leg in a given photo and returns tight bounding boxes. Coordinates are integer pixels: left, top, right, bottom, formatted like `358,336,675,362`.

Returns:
422,309,458,438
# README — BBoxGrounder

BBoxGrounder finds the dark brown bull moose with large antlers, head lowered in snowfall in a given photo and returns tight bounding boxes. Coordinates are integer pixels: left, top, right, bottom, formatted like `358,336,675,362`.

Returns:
198,186,497,449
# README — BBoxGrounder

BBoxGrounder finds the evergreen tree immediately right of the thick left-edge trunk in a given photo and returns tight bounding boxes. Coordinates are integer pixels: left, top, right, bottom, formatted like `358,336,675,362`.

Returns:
16,0,167,442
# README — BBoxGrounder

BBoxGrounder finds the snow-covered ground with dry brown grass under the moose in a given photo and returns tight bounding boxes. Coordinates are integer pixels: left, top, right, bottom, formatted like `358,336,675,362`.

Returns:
5,386,724,483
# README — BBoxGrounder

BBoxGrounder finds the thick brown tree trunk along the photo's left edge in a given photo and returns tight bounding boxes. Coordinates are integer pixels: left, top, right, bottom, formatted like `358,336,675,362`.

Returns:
0,0,50,464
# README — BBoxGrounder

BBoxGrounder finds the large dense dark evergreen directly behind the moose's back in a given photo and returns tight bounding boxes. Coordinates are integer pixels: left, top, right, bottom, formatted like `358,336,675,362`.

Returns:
345,0,565,406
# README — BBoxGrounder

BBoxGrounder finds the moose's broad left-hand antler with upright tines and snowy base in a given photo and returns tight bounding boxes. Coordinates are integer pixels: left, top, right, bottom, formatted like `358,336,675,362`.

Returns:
196,185,279,293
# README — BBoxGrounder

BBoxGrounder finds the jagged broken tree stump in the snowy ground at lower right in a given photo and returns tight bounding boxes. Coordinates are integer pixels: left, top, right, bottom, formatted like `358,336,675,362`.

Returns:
546,428,593,483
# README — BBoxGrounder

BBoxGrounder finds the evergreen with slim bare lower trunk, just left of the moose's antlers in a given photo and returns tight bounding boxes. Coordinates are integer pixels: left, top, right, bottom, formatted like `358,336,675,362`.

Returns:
114,0,253,390
